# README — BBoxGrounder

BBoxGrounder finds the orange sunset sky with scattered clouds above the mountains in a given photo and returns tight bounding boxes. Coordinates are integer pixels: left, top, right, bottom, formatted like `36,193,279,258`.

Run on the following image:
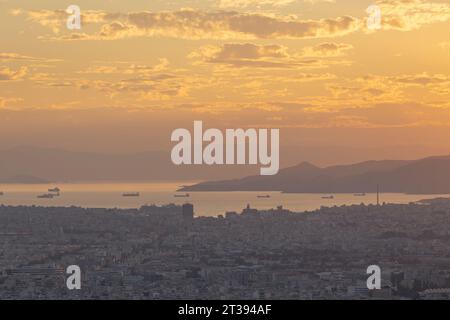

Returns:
0,0,450,165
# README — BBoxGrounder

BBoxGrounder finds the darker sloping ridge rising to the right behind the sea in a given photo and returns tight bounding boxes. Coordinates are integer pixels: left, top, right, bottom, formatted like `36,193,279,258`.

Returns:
180,156,450,194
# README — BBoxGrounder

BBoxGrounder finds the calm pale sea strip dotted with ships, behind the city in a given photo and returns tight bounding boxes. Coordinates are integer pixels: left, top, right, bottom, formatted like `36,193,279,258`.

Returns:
0,182,444,216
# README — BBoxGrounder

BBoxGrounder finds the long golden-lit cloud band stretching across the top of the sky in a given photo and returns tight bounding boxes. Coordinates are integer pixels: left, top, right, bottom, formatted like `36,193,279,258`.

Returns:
15,9,361,40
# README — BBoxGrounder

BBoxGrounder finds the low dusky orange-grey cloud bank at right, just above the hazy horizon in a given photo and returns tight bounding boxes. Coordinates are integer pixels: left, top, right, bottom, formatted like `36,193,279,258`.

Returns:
185,101,450,128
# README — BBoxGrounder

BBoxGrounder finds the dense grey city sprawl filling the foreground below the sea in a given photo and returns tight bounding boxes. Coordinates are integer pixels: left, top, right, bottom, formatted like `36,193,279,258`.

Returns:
0,198,450,300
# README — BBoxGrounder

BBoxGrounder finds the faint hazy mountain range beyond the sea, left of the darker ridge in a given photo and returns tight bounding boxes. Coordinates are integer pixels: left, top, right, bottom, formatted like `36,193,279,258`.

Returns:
0,146,259,183
